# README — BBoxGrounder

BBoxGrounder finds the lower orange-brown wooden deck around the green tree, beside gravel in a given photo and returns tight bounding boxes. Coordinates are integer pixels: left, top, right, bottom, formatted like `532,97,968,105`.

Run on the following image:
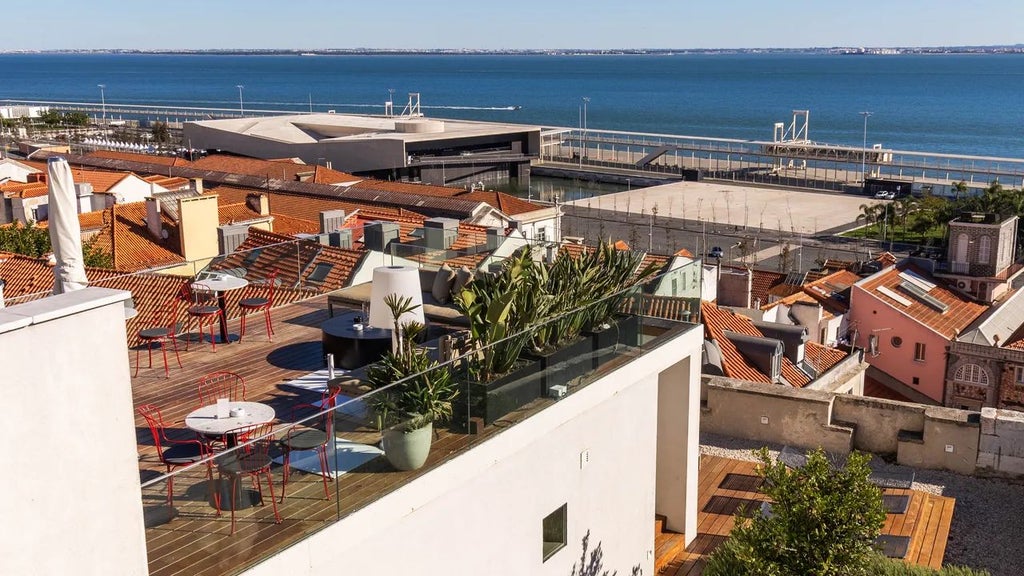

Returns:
654,454,954,576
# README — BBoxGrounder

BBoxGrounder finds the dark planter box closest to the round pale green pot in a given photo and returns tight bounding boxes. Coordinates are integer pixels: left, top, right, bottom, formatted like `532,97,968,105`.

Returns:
455,359,544,429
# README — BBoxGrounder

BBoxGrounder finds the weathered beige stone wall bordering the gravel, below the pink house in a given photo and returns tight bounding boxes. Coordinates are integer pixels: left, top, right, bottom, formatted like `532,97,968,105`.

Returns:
700,377,1003,476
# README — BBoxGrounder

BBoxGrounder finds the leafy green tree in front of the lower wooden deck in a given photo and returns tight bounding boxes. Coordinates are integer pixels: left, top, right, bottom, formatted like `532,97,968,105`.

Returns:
703,448,886,576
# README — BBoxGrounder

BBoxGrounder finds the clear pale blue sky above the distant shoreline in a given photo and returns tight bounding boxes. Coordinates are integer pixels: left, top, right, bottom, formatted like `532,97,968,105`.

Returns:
8,0,1024,50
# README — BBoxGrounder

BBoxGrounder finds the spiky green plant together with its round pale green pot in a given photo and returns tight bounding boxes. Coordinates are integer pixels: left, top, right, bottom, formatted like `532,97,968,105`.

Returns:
367,294,458,470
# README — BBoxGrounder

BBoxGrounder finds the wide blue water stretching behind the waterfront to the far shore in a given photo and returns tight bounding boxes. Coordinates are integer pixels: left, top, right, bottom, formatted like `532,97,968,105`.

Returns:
0,54,1024,158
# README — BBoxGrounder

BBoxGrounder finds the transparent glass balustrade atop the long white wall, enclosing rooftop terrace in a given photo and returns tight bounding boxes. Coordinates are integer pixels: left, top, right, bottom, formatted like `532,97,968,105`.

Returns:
141,260,700,573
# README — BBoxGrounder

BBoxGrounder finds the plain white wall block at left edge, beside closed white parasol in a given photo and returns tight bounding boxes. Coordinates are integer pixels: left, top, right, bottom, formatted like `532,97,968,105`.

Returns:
0,288,147,575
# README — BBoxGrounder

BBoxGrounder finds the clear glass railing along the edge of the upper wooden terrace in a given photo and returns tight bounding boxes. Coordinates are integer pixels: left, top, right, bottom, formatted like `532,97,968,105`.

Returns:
140,260,700,573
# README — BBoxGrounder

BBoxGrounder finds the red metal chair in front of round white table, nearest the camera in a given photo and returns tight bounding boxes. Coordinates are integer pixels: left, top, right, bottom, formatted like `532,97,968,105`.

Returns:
216,422,281,534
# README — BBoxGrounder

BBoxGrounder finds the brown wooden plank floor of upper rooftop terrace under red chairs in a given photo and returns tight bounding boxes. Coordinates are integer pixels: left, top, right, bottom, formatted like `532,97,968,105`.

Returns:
131,296,622,576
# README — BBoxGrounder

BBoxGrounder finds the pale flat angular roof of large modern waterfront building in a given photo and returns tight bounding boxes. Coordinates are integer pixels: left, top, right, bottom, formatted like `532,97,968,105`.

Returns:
188,114,541,143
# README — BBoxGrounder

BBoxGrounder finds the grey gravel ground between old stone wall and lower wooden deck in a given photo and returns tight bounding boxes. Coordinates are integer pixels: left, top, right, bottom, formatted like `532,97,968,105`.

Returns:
700,433,1024,576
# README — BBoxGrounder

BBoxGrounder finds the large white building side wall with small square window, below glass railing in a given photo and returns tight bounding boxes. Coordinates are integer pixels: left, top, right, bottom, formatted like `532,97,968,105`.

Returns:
246,319,701,576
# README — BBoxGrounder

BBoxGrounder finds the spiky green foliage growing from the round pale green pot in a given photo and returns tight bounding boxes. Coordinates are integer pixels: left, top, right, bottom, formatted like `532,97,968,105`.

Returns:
367,294,458,431
